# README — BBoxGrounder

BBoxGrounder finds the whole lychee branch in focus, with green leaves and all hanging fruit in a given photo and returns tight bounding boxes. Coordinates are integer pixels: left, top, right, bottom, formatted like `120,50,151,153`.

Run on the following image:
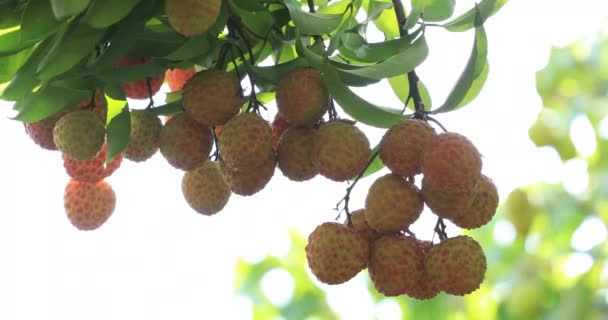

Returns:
0,0,506,299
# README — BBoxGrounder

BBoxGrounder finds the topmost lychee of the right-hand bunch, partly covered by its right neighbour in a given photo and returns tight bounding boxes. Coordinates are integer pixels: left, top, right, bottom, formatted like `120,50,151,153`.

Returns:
380,119,437,177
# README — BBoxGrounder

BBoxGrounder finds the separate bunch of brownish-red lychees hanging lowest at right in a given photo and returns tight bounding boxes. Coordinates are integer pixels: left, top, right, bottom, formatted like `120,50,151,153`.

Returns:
306,119,498,299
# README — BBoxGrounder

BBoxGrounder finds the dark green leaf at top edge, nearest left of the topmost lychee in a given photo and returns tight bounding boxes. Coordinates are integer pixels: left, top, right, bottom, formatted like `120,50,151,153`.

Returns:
82,0,140,29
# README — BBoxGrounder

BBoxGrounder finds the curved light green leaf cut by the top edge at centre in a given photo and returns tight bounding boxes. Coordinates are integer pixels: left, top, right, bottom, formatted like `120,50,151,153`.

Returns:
285,0,342,35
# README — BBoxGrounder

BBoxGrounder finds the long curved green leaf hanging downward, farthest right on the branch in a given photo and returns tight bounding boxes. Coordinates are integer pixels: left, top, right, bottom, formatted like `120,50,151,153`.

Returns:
433,16,489,113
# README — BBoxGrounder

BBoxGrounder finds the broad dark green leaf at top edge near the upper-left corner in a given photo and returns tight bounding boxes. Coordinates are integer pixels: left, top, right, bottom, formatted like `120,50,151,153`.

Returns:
21,1,61,44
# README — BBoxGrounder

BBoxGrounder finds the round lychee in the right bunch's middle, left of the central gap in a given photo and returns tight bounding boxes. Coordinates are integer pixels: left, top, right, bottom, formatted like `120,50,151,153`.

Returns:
365,174,424,233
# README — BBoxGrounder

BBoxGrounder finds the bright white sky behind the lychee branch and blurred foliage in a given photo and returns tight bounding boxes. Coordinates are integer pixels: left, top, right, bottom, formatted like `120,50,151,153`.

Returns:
0,0,608,320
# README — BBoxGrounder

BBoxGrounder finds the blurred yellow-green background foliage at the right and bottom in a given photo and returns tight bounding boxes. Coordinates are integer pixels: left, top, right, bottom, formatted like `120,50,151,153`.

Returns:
236,23,608,320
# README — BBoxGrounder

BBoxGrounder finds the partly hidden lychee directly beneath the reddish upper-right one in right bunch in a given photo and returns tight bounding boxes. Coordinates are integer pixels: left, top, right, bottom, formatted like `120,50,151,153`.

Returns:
422,177,477,220
